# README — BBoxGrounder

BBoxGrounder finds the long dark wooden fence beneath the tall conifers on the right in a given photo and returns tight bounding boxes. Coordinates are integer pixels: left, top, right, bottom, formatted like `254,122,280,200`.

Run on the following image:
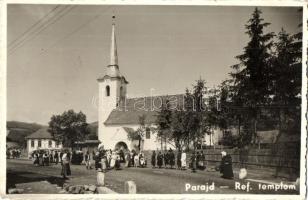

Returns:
145,144,300,177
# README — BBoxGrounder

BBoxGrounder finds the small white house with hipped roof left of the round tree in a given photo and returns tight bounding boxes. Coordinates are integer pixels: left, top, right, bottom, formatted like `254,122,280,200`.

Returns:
25,127,62,155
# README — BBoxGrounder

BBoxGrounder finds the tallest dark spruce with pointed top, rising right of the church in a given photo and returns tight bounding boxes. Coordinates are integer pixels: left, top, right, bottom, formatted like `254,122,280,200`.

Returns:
230,8,274,145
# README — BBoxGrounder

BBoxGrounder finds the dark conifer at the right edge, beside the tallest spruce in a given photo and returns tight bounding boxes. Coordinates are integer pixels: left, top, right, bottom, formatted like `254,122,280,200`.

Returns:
272,29,301,134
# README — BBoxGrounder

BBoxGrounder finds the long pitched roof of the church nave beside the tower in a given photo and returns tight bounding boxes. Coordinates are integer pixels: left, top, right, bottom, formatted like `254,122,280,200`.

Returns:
105,94,184,125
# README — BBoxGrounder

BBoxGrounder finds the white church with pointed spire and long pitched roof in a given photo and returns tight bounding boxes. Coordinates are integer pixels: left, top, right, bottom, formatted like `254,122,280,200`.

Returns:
97,16,220,150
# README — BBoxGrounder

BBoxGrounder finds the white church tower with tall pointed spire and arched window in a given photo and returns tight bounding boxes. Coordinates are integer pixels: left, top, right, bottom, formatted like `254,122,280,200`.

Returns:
97,16,128,146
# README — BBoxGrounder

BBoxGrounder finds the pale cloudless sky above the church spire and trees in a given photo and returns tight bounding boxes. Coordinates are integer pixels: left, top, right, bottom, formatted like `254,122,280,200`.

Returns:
7,4,302,125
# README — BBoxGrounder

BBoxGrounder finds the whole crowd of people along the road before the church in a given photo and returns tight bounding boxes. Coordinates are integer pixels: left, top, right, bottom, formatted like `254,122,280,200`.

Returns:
26,147,233,179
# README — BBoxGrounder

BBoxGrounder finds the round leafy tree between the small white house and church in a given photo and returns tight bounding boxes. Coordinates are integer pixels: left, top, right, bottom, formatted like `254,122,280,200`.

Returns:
49,110,89,147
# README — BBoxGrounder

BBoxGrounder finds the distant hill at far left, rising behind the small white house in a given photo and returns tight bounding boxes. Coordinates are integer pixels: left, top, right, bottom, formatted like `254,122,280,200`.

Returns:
6,121,46,146
